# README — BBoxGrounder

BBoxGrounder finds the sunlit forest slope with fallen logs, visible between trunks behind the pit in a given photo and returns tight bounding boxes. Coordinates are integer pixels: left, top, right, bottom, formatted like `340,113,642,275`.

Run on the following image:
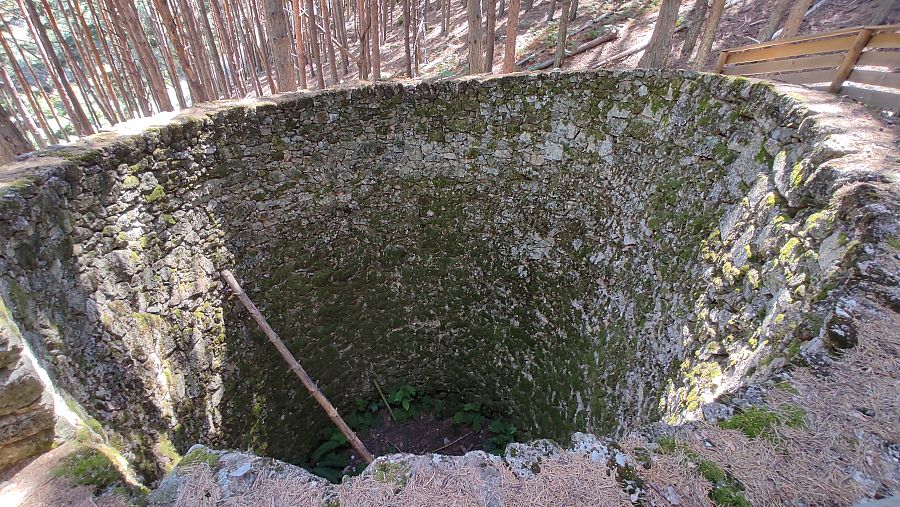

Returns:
312,0,900,83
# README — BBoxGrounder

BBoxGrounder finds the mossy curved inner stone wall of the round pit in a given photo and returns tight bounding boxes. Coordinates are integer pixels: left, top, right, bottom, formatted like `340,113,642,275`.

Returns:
0,71,870,476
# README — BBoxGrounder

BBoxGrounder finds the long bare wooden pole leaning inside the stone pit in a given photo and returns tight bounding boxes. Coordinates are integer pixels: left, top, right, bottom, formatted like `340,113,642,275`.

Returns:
222,269,375,463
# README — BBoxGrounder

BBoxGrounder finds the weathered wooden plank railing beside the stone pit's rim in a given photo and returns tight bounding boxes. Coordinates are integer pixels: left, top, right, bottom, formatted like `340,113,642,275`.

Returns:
715,25,900,111
